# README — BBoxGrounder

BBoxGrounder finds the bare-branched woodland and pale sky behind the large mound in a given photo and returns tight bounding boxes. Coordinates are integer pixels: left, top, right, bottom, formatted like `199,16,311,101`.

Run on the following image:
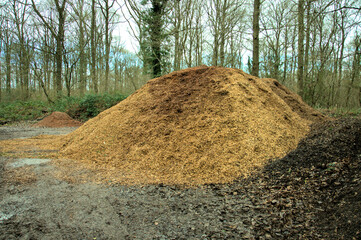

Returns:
0,0,361,109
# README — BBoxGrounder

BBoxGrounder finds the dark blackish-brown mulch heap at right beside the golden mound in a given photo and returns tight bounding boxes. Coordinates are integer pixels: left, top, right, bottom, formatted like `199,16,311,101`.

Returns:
238,118,361,239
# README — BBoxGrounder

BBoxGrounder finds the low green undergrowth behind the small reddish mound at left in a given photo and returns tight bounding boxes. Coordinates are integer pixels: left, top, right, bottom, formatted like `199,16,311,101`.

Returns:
0,94,126,124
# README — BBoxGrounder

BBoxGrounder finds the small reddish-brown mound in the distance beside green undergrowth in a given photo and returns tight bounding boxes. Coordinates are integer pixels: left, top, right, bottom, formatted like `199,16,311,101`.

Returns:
33,112,82,128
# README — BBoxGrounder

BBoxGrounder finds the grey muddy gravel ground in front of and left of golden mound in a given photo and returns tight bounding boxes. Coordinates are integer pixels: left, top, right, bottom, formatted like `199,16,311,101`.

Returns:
0,124,262,239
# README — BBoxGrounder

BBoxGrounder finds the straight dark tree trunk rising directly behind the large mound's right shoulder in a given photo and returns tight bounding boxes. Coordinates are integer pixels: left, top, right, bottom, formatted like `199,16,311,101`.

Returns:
251,0,261,77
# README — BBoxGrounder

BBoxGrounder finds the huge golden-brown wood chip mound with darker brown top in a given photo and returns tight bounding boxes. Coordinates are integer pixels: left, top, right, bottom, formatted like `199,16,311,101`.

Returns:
61,66,323,185
